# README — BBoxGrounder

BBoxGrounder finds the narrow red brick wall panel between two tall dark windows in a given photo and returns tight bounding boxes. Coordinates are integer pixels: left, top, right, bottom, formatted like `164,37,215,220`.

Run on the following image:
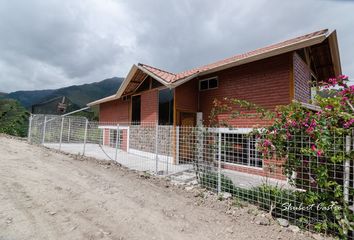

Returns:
141,89,159,123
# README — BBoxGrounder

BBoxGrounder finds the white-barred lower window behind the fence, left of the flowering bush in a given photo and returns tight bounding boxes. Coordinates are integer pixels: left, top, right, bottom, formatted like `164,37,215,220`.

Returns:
221,133,262,167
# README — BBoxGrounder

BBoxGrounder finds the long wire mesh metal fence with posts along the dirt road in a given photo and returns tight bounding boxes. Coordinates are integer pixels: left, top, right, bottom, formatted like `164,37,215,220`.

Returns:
28,115,354,238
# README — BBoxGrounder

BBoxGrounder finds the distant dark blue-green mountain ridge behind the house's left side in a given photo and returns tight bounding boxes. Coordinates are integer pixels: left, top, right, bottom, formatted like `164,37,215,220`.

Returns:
5,77,123,109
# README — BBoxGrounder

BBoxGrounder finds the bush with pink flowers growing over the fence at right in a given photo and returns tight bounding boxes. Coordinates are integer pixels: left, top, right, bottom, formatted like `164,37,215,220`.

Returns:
211,75,354,238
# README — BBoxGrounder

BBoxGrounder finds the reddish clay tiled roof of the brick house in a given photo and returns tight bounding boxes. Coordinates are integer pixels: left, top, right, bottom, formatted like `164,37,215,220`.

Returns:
139,29,328,83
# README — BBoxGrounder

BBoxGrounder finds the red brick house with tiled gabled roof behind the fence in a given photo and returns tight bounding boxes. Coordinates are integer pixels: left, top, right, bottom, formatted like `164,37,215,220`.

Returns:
88,29,341,177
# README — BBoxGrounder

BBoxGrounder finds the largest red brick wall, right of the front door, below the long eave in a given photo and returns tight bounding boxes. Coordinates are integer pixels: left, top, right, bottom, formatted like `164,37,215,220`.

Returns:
195,53,292,127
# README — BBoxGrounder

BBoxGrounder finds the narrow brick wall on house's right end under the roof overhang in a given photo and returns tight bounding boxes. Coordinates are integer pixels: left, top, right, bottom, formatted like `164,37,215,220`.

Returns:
293,53,311,103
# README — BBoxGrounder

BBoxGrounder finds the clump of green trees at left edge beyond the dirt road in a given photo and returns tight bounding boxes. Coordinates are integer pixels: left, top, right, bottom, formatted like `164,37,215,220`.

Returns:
0,99,29,137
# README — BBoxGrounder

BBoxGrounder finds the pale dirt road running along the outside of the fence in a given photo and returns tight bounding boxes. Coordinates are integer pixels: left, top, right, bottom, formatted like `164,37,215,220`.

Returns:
0,136,320,240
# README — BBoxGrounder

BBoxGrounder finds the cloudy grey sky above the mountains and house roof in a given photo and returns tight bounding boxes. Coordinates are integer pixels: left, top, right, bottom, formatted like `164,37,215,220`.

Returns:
0,0,354,92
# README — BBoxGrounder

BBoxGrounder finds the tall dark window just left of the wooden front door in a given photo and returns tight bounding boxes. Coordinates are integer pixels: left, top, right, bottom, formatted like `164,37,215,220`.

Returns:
159,89,173,125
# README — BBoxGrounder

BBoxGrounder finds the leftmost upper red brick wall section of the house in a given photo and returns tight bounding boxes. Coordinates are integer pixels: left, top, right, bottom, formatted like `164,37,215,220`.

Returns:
99,99,130,124
